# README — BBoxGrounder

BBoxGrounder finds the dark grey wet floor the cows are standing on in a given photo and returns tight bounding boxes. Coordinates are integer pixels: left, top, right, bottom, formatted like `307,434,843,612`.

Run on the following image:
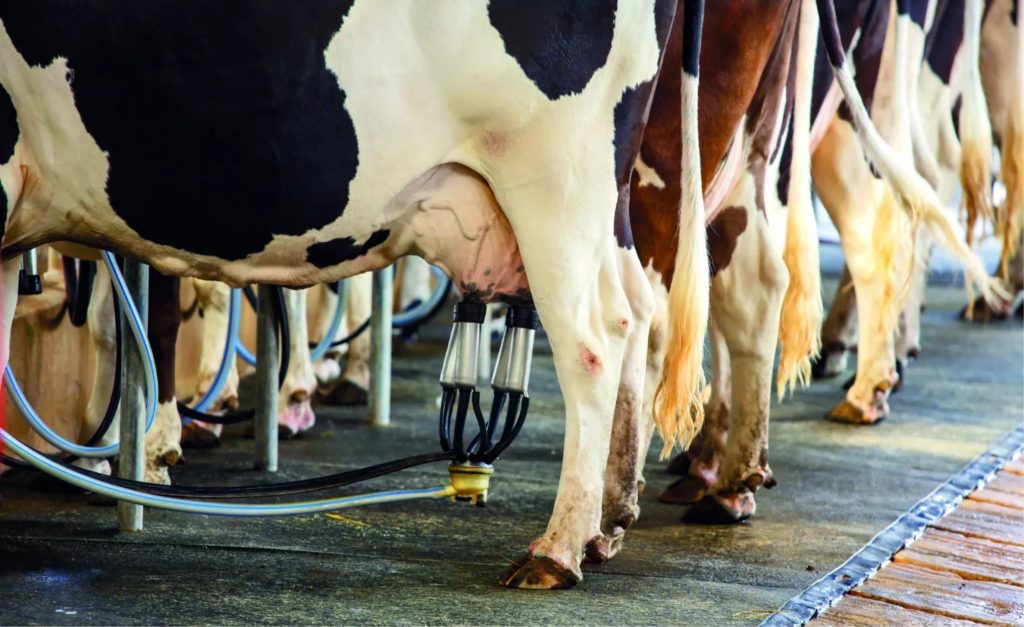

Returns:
0,253,1024,625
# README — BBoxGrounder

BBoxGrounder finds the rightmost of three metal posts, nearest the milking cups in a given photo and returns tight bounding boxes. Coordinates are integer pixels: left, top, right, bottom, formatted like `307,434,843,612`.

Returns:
369,267,394,426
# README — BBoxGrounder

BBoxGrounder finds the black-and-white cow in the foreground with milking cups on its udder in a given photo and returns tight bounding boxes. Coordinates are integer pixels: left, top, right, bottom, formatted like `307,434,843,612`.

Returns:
0,0,708,588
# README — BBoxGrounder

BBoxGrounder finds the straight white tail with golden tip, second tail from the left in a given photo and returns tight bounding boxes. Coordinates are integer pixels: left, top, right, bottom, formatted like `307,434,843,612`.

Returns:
775,0,823,400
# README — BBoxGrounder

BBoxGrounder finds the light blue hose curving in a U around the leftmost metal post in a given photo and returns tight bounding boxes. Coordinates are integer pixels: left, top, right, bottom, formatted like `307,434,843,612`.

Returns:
4,251,157,458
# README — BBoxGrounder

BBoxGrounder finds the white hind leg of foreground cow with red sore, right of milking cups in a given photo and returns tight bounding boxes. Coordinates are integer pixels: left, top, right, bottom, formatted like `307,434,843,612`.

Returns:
501,214,634,589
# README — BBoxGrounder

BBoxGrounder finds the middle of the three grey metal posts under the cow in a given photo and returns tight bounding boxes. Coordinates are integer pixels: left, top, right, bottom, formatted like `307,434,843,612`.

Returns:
253,285,279,472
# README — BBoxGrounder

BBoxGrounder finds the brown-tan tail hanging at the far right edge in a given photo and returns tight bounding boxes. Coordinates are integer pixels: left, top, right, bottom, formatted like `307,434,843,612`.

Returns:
996,11,1024,281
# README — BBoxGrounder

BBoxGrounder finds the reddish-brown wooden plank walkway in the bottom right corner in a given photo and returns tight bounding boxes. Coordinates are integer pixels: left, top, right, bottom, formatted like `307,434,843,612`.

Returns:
811,457,1024,627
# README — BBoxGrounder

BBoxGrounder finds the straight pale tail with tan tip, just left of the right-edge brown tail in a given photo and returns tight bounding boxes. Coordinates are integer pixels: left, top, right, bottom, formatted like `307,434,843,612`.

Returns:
959,0,992,257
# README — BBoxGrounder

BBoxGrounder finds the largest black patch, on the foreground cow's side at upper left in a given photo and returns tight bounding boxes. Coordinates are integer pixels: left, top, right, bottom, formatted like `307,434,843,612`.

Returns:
0,0,358,259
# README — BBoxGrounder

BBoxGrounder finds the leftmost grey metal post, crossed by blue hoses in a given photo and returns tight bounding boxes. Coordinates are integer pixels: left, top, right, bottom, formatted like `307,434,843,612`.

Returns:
118,260,150,532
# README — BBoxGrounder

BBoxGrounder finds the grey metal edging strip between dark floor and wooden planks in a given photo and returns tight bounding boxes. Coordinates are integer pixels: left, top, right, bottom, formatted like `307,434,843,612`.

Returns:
761,425,1024,627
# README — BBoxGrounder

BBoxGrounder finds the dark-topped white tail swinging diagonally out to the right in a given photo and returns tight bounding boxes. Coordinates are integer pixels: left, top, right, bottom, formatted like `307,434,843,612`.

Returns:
816,0,1008,307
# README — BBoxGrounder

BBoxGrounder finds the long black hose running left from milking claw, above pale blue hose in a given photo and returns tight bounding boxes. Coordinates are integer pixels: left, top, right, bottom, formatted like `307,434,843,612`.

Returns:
64,453,452,499
